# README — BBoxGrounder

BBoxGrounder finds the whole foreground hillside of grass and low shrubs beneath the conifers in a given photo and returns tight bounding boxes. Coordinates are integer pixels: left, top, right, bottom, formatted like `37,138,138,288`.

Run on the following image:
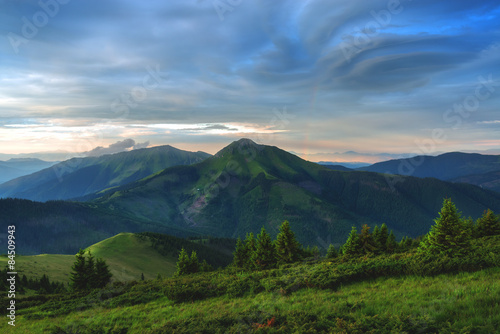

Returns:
4,236,500,334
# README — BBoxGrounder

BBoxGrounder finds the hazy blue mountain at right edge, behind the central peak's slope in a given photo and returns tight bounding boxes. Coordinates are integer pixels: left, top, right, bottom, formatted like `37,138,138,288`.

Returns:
358,152,500,180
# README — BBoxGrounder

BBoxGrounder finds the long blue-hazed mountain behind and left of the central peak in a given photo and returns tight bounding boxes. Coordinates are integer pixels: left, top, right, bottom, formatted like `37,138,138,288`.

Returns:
0,145,210,201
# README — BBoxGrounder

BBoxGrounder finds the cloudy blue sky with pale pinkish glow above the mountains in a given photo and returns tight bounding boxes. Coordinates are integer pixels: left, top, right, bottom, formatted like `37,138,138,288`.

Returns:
0,0,500,162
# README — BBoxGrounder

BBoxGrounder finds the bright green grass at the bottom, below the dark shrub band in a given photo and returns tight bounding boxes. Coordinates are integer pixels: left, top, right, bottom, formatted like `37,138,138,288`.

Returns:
4,268,500,333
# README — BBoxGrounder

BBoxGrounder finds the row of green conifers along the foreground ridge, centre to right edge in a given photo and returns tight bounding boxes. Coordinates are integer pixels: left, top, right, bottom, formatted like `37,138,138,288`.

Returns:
177,199,500,275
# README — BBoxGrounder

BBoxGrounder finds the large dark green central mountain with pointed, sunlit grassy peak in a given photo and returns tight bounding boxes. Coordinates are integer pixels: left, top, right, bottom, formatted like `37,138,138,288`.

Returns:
92,139,500,245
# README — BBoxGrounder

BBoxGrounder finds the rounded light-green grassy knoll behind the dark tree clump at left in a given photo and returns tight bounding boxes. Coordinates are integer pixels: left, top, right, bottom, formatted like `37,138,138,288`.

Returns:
0,233,231,284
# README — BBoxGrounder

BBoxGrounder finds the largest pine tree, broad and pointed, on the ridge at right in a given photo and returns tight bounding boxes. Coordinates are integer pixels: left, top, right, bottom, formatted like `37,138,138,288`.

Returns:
419,199,469,255
